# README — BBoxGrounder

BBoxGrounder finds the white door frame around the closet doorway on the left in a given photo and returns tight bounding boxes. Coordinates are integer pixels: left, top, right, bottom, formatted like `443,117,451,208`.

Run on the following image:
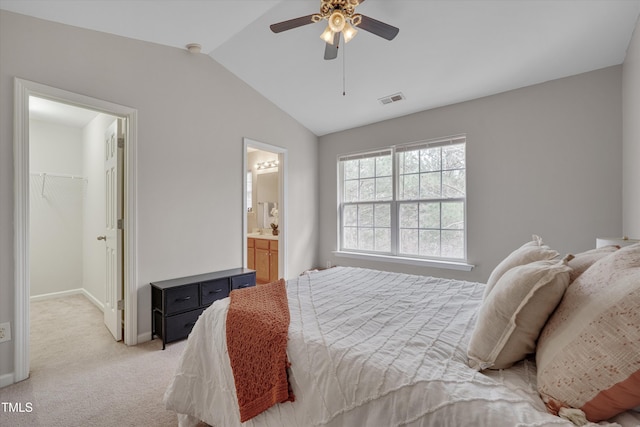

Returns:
13,77,138,382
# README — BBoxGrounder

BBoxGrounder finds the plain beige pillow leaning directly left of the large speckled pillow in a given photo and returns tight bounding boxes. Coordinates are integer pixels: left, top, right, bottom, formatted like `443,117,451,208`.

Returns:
467,255,572,371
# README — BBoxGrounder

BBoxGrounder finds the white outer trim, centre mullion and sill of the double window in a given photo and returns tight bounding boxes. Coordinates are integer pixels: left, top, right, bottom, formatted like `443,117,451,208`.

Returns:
332,134,475,271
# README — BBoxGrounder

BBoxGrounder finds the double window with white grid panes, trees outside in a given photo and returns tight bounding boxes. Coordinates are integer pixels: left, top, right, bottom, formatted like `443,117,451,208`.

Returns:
338,136,466,261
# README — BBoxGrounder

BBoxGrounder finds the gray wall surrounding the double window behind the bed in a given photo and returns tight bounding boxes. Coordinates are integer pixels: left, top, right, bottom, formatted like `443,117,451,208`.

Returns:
318,66,622,281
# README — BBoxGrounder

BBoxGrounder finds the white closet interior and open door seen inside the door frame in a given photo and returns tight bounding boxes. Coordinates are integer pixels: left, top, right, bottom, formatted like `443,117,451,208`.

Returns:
29,96,126,341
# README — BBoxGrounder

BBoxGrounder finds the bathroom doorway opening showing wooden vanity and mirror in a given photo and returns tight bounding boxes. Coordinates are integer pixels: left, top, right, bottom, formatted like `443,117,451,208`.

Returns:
242,138,288,283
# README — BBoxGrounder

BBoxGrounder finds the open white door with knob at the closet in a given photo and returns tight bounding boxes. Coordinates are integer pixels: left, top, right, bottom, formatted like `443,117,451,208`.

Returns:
98,119,124,341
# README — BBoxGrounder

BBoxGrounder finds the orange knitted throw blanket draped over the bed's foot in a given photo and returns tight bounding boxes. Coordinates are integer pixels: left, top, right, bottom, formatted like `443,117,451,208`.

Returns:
227,279,295,422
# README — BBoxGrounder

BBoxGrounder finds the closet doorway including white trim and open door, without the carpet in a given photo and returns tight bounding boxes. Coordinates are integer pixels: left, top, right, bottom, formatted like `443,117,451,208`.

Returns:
14,79,137,382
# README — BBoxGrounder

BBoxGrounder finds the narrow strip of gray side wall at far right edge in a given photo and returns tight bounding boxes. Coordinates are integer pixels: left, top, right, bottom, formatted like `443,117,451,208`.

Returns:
622,18,640,239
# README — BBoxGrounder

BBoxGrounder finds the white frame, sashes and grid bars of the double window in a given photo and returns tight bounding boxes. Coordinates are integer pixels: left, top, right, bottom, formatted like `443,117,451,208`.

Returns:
334,134,473,271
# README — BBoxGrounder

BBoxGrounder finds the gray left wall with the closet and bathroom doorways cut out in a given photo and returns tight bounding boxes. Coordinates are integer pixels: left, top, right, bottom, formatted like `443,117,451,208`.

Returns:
0,11,318,377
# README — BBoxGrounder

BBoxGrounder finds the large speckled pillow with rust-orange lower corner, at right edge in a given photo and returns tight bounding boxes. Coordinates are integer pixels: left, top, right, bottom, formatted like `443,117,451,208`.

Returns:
536,244,640,422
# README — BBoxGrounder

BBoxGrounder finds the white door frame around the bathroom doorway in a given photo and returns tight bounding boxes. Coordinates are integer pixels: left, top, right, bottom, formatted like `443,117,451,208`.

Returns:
241,138,289,279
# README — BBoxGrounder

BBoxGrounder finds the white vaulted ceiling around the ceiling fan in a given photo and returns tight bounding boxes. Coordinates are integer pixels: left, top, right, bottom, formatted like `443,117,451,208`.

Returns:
0,0,640,135
